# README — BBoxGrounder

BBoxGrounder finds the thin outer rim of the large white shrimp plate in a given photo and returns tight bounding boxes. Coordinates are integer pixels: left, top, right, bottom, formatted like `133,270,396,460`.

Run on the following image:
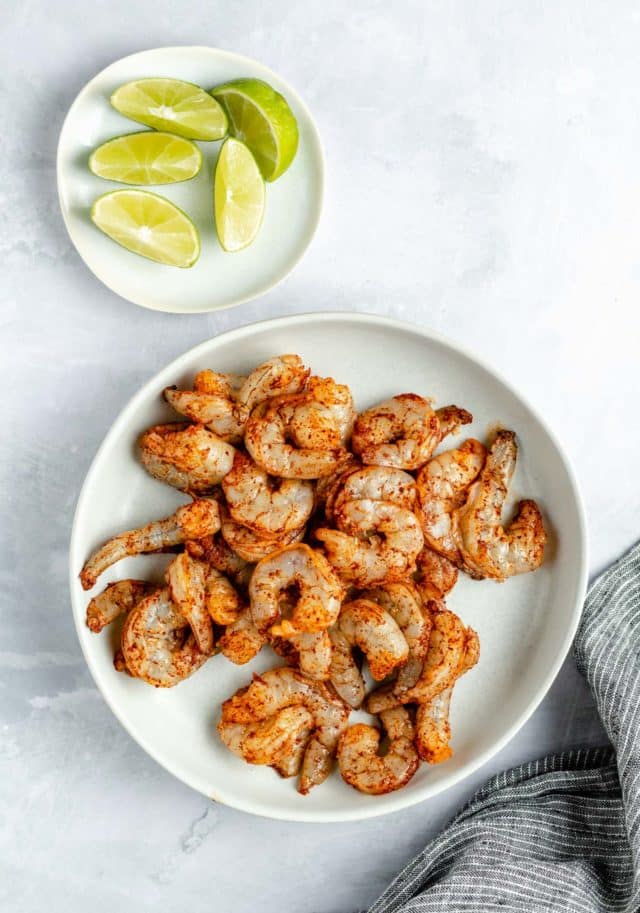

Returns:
69,311,588,824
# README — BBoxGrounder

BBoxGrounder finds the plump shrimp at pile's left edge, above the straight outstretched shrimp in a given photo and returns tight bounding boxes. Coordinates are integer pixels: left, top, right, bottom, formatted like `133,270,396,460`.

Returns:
139,422,235,494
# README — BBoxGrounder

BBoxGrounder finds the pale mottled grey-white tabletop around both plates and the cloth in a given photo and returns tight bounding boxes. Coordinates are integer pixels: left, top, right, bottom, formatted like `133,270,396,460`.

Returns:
0,0,640,913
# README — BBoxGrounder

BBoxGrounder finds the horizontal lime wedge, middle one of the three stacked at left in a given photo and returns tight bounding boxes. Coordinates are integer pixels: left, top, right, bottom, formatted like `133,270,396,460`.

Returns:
89,131,202,184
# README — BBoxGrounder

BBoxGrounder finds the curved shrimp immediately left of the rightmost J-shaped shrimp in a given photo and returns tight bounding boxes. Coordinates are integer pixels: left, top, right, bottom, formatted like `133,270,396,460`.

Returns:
416,438,486,565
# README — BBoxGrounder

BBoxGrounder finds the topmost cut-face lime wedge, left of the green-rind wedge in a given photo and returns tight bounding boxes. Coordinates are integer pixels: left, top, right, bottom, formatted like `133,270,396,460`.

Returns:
111,79,227,140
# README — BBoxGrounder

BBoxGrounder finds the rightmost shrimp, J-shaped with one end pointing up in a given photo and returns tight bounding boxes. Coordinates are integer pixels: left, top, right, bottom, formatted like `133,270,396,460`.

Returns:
454,431,547,580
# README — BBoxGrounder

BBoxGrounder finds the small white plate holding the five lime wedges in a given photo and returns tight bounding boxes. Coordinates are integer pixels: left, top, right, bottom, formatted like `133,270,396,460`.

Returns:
57,47,324,314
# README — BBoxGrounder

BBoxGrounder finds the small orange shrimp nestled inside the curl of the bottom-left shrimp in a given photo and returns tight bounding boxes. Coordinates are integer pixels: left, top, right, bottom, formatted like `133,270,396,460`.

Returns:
217,706,313,777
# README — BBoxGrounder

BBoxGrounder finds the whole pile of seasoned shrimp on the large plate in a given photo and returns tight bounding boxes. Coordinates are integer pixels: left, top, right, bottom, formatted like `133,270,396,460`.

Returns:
80,355,546,795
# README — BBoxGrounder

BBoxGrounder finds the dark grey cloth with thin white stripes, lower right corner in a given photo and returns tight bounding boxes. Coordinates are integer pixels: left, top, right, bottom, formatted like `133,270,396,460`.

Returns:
369,544,640,913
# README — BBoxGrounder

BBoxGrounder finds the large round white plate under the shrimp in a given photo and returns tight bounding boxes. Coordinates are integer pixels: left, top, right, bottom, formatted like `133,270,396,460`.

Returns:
70,313,586,821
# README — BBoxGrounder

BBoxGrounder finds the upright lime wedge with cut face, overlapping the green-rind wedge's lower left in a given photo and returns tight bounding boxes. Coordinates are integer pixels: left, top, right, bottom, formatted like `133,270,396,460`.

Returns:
213,137,265,251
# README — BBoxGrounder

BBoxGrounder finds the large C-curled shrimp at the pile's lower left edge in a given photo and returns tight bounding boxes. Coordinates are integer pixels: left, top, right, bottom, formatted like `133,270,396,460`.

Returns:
121,587,208,688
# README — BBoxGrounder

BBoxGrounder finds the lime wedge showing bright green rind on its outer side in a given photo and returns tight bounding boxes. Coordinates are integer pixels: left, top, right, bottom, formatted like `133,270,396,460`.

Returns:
211,79,298,181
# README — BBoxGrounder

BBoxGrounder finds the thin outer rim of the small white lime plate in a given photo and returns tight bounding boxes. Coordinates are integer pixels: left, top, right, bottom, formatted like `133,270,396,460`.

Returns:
56,44,327,314
